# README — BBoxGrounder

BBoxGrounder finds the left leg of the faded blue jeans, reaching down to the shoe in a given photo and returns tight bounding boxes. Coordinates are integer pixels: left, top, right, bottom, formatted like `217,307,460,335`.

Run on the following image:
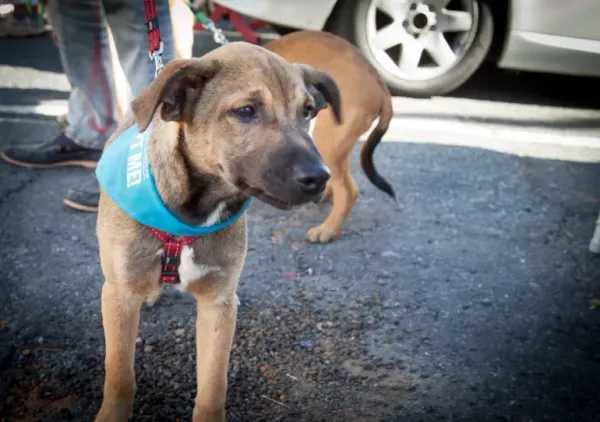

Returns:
48,0,120,149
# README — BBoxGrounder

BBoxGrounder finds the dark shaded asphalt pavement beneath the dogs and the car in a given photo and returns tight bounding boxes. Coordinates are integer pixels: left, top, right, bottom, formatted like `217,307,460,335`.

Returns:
0,30,600,422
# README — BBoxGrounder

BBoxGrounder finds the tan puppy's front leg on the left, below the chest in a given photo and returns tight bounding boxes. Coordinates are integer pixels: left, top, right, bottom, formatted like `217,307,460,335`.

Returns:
96,281,142,422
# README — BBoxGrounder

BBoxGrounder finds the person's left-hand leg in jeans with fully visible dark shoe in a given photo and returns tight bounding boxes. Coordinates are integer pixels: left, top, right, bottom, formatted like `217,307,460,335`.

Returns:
2,0,117,168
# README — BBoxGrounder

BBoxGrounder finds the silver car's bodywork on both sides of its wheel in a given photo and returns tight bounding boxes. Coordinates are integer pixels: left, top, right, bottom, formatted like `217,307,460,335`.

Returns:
217,0,600,76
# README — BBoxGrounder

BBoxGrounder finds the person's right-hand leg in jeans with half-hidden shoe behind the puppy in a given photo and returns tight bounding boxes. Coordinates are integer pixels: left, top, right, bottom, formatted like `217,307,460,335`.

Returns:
64,0,175,211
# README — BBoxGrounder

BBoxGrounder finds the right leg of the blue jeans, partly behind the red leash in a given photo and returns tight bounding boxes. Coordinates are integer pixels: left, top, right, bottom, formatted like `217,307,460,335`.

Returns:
105,0,175,99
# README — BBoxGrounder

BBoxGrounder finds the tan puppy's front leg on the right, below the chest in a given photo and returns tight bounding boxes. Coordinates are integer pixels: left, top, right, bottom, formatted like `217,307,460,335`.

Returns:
193,282,238,422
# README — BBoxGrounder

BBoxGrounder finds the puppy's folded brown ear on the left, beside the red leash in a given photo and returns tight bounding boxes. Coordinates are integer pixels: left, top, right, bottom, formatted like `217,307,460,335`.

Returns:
131,59,219,132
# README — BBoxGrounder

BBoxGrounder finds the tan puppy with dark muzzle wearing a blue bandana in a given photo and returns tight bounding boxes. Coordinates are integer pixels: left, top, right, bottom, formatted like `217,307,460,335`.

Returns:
96,42,340,422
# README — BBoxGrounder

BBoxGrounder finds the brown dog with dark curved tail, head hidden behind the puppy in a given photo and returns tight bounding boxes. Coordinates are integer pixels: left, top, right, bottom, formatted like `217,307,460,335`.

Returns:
264,31,396,243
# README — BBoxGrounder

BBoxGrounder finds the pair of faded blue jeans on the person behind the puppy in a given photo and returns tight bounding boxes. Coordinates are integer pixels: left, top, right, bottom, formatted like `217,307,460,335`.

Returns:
48,0,175,149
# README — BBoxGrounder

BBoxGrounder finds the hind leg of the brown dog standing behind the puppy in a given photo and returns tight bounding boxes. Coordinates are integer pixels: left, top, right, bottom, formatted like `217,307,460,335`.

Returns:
306,117,359,243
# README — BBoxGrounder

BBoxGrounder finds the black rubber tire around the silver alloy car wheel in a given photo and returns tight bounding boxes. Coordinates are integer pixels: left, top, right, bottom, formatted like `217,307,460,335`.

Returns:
324,0,494,97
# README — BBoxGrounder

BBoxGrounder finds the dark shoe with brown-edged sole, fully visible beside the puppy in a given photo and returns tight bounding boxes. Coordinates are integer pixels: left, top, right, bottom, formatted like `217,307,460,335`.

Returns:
0,133,102,169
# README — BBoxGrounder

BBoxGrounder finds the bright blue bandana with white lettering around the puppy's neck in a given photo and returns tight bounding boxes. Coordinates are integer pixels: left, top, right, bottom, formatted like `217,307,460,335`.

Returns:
96,124,251,236
